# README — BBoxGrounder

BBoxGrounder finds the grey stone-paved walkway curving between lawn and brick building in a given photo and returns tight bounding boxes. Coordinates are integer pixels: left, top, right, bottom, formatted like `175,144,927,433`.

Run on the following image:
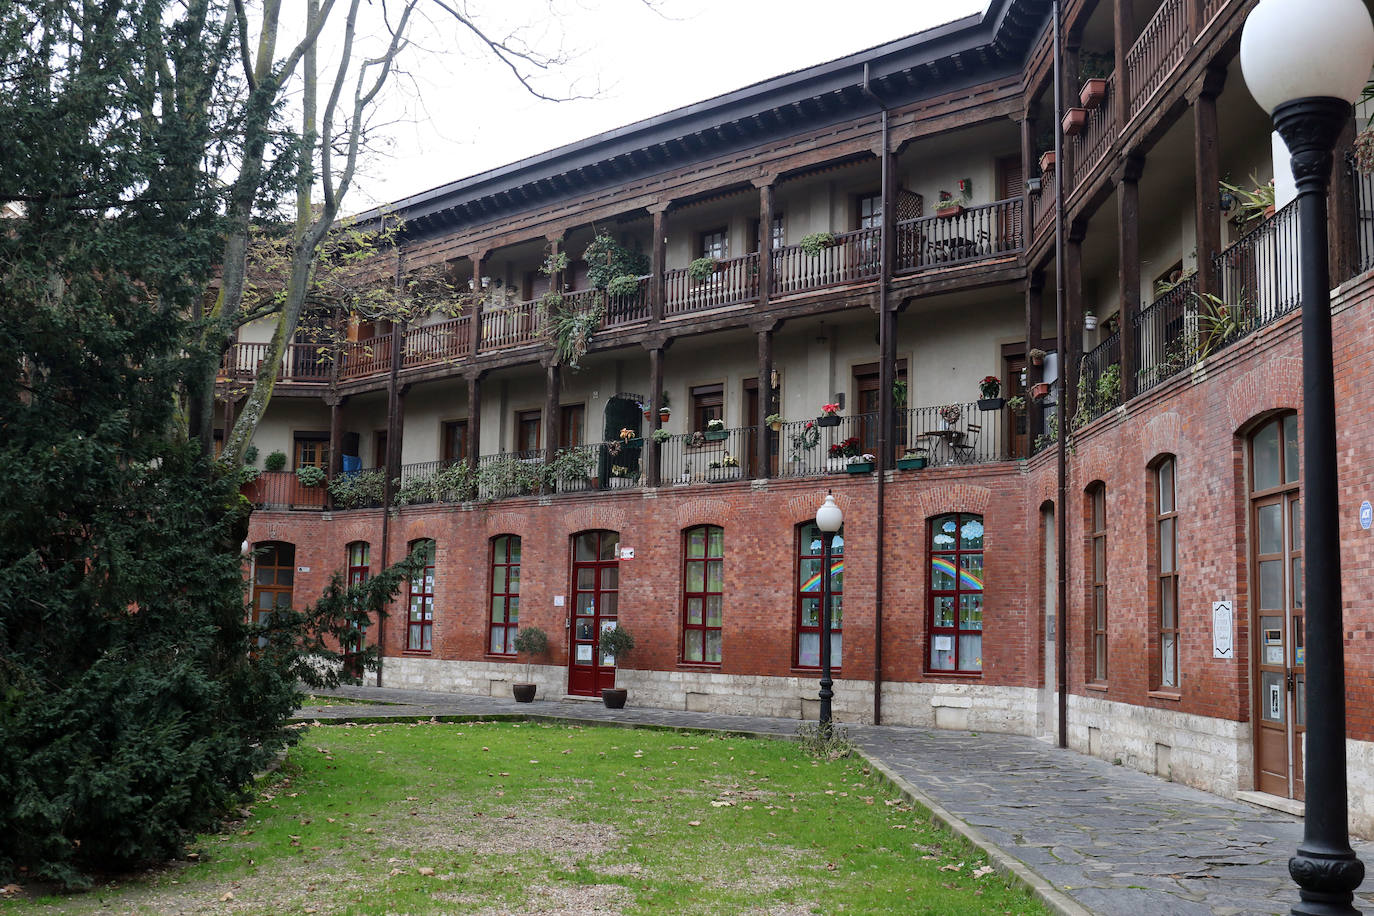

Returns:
300,687,1374,916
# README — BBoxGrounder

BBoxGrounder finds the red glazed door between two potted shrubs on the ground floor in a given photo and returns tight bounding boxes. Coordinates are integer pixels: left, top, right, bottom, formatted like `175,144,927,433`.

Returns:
567,531,620,696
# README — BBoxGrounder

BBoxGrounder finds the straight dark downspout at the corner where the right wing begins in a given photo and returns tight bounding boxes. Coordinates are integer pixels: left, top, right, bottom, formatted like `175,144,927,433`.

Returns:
1050,0,1069,747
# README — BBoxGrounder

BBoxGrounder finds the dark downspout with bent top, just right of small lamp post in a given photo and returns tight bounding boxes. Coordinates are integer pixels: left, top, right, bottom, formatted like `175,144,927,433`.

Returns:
860,63,894,725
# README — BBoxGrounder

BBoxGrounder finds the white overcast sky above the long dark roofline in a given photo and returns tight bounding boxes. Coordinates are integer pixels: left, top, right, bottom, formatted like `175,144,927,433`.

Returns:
345,0,987,211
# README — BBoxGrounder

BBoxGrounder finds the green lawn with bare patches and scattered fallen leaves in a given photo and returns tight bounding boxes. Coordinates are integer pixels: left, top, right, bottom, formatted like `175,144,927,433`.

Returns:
0,722,1047,916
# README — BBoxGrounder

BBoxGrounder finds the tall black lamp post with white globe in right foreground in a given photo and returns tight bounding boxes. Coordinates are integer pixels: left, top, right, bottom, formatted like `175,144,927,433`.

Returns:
1241,0,1374,916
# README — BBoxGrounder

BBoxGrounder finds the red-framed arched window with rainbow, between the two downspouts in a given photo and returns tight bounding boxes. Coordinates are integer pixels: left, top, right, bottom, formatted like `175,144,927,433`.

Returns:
926,512,985,674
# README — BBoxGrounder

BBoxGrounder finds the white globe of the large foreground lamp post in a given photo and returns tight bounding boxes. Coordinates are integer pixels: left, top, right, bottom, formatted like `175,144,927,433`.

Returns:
1241,0,1374,114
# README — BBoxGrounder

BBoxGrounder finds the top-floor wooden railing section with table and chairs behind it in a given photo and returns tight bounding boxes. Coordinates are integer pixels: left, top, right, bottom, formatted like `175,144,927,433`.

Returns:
897,198,1025,271
